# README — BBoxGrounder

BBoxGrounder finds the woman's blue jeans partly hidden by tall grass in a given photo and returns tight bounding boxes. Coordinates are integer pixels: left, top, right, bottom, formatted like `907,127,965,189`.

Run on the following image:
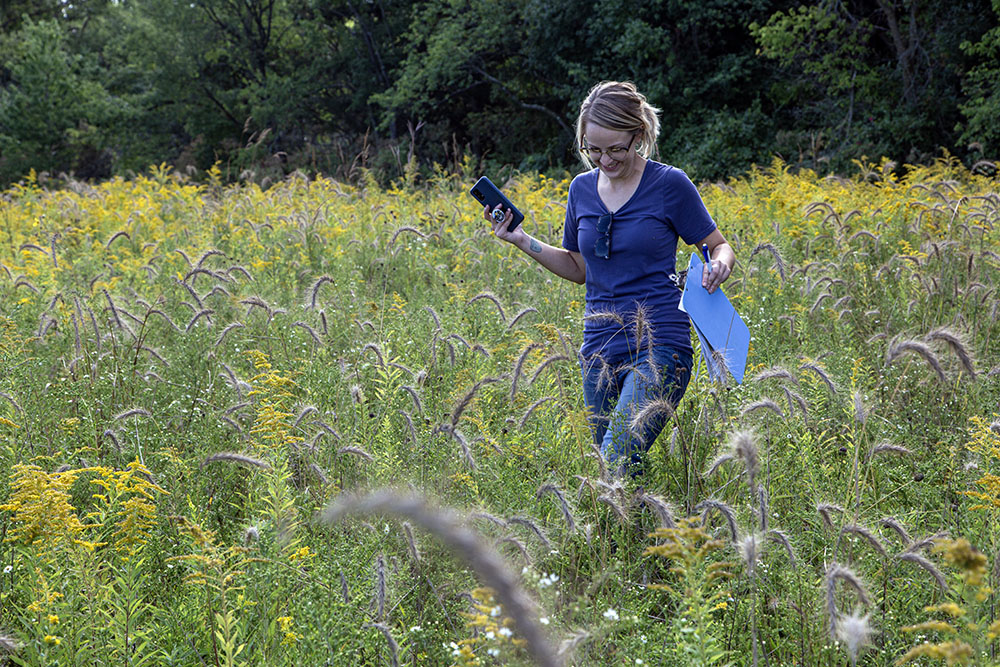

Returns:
582,345,692,477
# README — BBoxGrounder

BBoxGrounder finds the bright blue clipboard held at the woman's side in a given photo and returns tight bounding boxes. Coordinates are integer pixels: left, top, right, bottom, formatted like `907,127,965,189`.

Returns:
680,252,750,384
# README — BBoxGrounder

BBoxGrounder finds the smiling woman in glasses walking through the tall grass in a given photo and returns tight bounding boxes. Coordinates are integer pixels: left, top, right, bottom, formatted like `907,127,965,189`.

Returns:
484,81,736,476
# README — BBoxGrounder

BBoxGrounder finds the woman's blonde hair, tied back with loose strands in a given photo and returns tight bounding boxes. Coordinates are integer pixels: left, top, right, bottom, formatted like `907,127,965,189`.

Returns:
576,81,660,168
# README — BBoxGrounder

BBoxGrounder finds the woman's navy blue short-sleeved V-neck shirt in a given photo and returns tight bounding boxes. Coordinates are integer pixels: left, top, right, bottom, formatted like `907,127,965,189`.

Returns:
563,160,715,363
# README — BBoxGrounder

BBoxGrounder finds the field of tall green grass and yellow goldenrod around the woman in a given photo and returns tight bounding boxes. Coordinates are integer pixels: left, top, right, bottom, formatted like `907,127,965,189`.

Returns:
0,158,1000,666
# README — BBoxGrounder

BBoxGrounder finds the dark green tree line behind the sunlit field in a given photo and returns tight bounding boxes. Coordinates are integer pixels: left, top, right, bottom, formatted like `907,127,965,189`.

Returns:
0,0,1000,185
